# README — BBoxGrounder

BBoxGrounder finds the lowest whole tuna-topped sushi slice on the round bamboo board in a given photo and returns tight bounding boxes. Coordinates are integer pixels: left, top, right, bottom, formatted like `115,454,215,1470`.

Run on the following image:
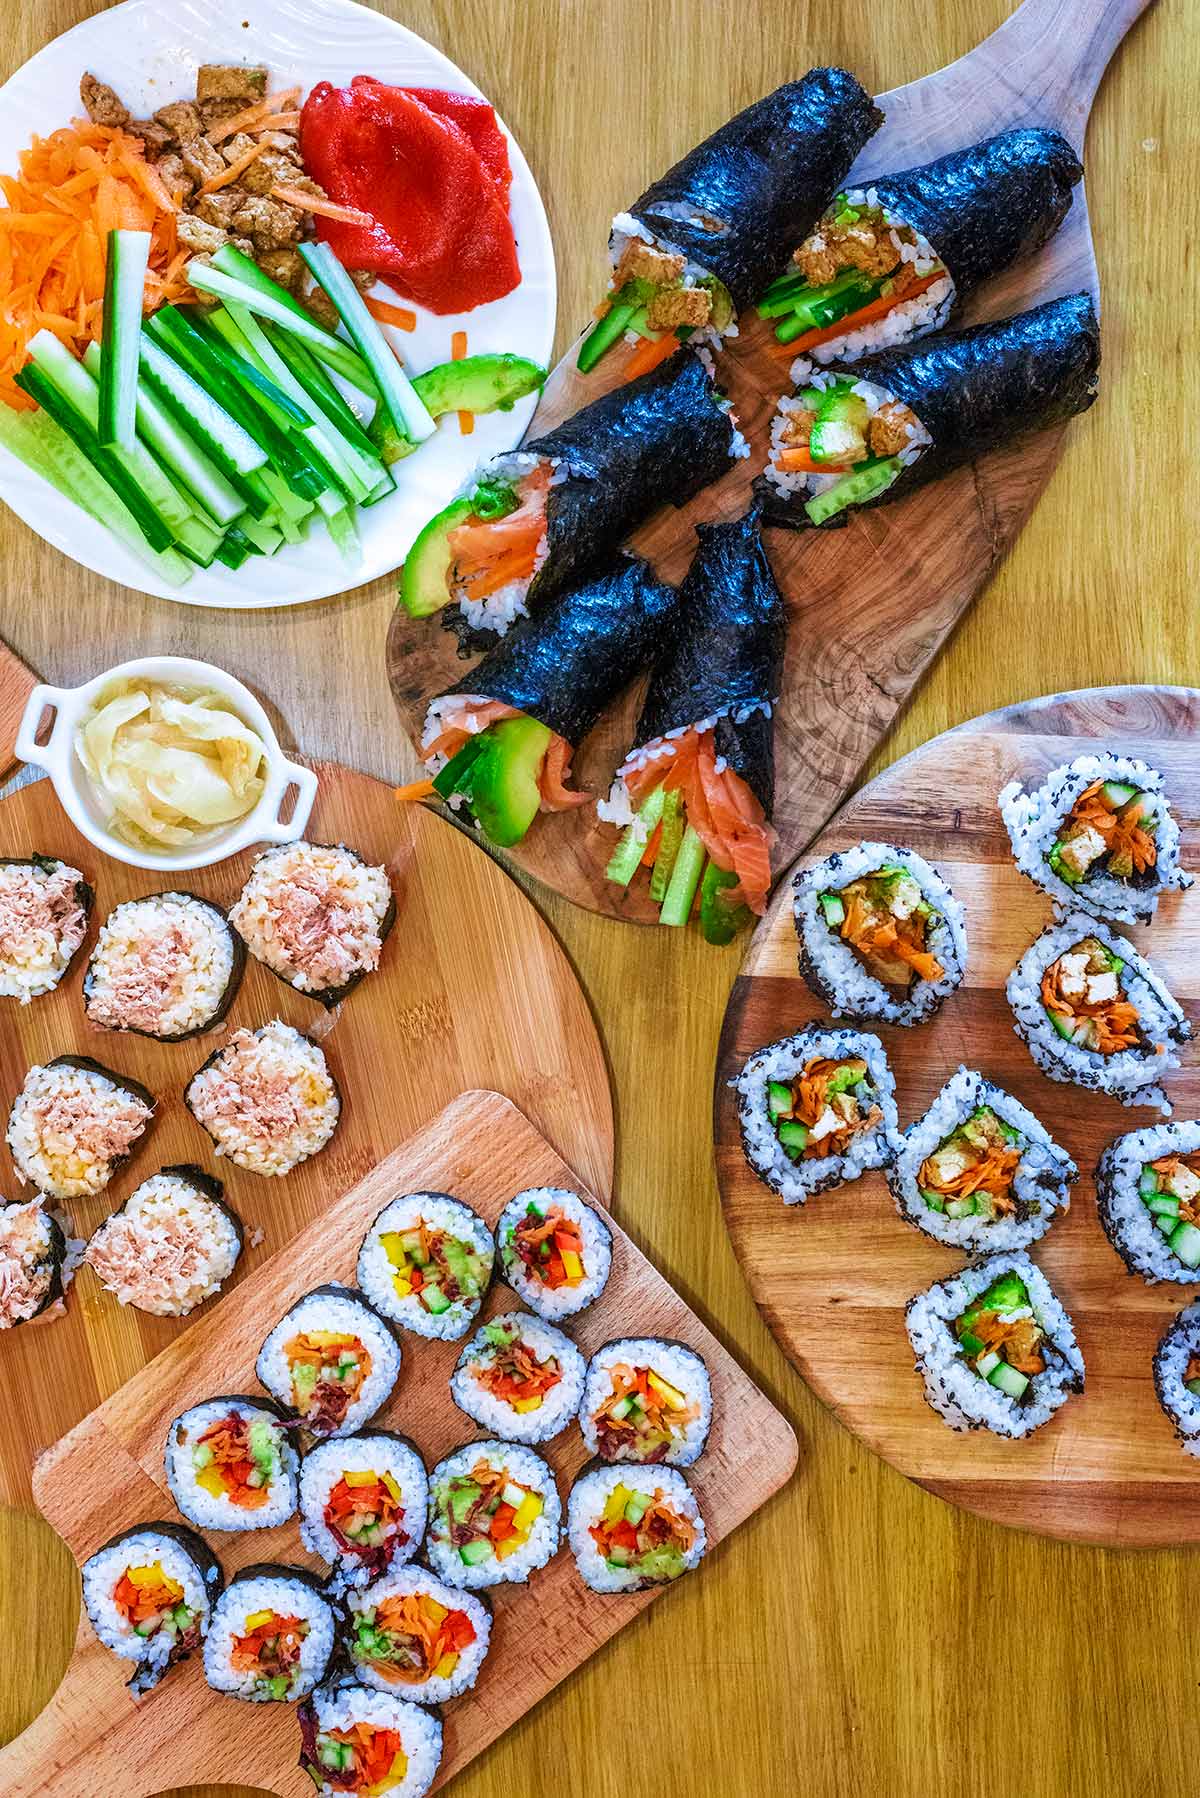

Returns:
85,1163,243,1318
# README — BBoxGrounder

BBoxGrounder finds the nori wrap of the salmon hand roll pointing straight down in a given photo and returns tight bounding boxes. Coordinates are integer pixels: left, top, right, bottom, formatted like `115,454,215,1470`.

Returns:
635,507,788,818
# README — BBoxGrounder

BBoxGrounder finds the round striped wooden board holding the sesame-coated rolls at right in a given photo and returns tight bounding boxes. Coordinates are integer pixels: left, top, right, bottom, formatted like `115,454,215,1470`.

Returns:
714,687,1200,1546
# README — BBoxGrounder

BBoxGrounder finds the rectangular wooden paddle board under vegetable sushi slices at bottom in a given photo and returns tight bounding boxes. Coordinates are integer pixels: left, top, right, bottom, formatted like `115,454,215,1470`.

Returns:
0,1091,797,1798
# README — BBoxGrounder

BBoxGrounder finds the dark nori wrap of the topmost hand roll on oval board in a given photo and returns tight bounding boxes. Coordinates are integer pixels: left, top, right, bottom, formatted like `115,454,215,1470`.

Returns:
630,68,883,311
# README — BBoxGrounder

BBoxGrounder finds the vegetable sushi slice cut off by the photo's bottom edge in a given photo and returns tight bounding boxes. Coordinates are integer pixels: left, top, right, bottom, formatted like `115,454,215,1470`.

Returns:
297,1681,443,1798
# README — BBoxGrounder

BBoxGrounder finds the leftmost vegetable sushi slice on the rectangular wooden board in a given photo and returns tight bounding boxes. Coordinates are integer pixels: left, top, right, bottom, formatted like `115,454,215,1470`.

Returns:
83,1523,225,1697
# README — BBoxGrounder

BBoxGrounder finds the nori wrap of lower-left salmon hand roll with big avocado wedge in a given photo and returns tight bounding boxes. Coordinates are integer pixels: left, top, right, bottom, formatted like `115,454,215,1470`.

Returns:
450,556,680,748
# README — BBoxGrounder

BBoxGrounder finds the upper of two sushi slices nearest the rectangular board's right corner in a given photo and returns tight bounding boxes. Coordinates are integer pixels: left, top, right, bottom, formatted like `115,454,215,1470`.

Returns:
579,1336,712,1467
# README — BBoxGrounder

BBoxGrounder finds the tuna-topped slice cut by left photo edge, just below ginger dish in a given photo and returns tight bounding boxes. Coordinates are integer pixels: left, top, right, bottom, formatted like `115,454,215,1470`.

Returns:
0,856,95,1005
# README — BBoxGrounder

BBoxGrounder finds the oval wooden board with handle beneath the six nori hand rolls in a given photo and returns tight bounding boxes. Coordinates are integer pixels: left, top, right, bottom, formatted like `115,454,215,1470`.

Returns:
387,0,1150,924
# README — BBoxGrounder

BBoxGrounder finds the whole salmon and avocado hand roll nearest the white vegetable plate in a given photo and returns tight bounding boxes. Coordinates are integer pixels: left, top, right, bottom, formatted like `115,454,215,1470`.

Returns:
399,351,750,644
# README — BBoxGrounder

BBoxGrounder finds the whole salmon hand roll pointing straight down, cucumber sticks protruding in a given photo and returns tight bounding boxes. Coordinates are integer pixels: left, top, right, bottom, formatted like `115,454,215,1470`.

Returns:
597,511,788,944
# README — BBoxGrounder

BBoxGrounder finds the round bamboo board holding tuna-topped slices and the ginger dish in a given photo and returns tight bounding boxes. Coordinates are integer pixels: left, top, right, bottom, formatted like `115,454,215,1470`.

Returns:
0,762,613,1505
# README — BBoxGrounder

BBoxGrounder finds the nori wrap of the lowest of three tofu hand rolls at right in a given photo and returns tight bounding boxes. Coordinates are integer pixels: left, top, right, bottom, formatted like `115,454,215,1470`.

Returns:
754,293,1099,530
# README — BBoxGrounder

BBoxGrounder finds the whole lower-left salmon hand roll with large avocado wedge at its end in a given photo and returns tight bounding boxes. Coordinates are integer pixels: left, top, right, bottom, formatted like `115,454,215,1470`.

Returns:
410,556,678,847
